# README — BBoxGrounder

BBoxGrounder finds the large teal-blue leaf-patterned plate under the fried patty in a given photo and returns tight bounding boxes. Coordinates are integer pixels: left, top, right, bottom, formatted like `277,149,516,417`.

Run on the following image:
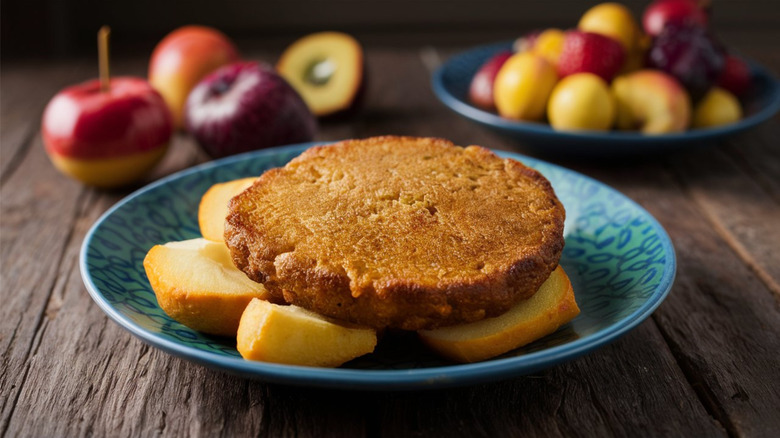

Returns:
80,143,676,390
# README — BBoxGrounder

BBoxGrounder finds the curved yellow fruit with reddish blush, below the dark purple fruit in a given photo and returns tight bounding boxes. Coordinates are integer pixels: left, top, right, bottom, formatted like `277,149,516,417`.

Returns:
612,70,691,134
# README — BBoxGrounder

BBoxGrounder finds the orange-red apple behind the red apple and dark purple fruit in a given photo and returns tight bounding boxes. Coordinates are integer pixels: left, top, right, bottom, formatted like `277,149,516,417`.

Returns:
149,26,239,128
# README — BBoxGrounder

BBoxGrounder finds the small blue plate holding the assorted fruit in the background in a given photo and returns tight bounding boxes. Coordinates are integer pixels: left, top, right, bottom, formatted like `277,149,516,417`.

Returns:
432,39,780,156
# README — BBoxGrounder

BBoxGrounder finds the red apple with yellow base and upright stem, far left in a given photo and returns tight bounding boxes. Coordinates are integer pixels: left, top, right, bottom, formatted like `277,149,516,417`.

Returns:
41,77,173,187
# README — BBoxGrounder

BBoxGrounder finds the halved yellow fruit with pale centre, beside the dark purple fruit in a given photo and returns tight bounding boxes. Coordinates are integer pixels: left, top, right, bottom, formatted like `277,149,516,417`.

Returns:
276,32,364,117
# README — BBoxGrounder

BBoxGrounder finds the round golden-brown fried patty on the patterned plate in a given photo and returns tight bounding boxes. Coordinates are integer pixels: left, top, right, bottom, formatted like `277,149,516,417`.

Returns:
225,137,565,330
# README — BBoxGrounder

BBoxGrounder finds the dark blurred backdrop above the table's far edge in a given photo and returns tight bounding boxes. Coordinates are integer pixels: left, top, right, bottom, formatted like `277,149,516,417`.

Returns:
0,0,780,60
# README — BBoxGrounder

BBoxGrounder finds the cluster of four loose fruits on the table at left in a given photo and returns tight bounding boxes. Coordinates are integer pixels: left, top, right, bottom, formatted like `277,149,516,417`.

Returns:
42,26,364,188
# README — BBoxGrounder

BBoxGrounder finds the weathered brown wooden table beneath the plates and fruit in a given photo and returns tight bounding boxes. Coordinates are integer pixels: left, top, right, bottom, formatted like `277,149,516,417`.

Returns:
0,32,780,437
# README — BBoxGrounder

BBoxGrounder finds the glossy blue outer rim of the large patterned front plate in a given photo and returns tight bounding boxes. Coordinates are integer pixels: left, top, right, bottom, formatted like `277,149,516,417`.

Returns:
79,142,677,390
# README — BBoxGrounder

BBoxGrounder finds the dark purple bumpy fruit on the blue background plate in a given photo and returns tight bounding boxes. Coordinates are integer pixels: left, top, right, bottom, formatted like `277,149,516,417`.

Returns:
647,22,726,101
